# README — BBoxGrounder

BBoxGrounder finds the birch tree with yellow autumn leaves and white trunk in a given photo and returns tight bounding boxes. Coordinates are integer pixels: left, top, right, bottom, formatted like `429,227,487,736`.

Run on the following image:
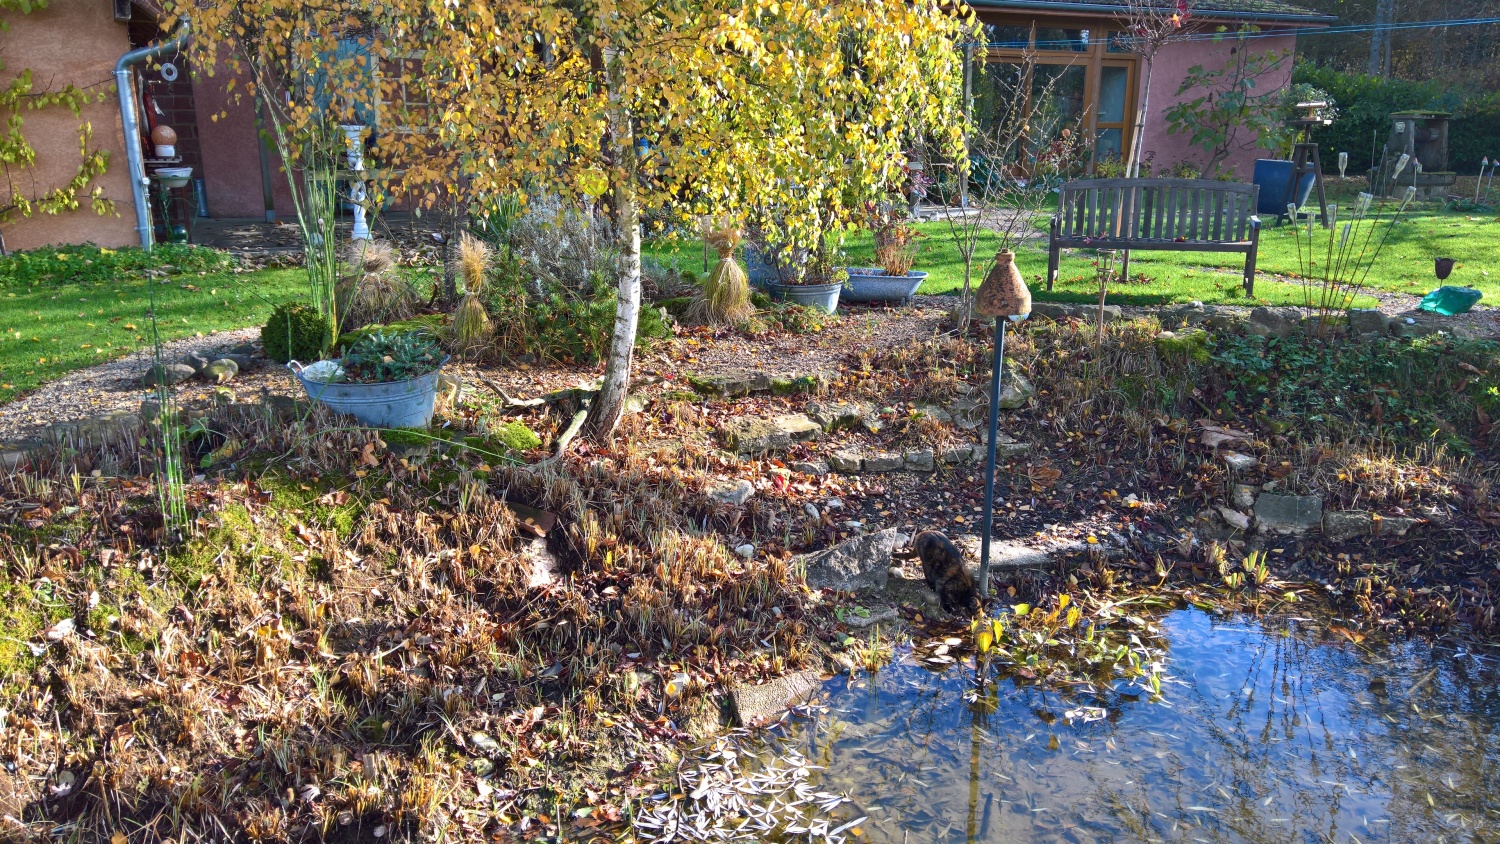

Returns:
367,0,960,436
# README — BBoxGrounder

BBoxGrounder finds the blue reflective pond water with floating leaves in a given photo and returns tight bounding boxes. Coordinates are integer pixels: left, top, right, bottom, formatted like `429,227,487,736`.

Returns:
768,610,1500,844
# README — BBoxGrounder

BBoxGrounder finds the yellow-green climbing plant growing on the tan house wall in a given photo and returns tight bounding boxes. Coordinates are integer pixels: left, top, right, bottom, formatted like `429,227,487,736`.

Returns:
0,0,114,255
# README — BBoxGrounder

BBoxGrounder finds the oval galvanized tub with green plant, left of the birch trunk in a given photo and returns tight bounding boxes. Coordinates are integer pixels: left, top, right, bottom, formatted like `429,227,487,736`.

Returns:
287,331,449,427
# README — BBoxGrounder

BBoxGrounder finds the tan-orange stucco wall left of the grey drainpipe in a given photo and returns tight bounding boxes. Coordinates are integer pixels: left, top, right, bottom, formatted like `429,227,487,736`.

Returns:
0,0,138,249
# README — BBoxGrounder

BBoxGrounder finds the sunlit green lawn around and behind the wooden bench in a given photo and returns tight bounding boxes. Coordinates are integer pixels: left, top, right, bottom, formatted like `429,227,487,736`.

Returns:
647,211,1500,304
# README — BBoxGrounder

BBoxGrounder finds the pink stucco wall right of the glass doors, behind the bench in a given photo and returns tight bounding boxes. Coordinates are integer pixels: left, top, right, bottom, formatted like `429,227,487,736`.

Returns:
1137,33,1296,181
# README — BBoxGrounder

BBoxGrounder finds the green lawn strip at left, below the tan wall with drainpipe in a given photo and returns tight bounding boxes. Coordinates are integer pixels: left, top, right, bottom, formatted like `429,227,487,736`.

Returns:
0,270,308,403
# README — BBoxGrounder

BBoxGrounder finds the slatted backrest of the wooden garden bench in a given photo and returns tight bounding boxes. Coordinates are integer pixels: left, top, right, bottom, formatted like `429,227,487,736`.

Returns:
1058,178,1260,243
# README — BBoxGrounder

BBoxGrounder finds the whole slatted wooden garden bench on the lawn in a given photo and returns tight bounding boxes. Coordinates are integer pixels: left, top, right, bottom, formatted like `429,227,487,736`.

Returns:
1047,178,1260,295
